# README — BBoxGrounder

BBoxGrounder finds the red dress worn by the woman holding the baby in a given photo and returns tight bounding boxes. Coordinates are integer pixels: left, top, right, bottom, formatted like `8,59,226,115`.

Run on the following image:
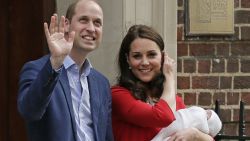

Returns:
112,86,185,141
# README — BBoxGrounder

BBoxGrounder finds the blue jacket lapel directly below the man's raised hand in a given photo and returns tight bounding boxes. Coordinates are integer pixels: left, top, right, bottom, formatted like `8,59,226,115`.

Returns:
59,67,76,138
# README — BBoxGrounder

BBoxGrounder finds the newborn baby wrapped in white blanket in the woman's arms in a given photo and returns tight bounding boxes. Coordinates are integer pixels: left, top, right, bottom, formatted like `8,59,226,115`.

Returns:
151,106,222,141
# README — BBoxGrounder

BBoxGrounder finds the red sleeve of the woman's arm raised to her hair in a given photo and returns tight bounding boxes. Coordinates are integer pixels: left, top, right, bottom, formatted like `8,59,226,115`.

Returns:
112,87,175,127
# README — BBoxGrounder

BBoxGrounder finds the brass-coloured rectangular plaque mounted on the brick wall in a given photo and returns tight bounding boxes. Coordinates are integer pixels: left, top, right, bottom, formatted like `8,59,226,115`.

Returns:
186,0,234,35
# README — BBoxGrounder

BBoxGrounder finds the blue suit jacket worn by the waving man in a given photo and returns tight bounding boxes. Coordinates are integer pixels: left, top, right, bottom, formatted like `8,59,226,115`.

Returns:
18,55,113,141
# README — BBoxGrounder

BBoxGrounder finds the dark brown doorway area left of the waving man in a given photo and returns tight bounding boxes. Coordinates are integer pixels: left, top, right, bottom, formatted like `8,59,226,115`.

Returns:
0,0,56,141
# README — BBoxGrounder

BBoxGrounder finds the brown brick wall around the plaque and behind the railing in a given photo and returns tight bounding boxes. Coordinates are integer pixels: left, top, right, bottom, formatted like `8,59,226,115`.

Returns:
177,0,250,135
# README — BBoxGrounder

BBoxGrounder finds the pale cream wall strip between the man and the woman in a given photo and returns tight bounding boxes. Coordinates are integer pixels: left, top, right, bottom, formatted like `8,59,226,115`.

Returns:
89,0,123,84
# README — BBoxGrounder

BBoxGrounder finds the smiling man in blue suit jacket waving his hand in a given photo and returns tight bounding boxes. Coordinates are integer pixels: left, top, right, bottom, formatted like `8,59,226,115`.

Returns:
18,0,113,141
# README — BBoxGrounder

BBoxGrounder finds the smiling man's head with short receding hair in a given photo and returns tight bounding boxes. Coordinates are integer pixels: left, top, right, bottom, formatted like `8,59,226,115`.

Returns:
69,0,103,52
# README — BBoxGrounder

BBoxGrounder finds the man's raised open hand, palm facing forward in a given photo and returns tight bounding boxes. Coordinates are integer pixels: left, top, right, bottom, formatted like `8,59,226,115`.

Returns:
44,14,75,69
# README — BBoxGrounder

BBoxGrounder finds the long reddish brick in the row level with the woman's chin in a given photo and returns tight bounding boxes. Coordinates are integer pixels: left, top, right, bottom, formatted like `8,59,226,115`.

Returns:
192,76,219,89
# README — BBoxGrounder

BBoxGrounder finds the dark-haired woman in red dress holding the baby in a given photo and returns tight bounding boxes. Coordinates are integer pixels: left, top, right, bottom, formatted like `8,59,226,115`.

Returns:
112,25,213,141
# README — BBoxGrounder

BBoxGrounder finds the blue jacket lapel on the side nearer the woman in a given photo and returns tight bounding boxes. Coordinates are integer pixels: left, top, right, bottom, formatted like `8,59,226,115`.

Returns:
88,73,101,132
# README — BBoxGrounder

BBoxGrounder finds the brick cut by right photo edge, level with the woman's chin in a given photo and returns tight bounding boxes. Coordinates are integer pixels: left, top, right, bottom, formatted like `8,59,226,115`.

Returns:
234,76,250,89
